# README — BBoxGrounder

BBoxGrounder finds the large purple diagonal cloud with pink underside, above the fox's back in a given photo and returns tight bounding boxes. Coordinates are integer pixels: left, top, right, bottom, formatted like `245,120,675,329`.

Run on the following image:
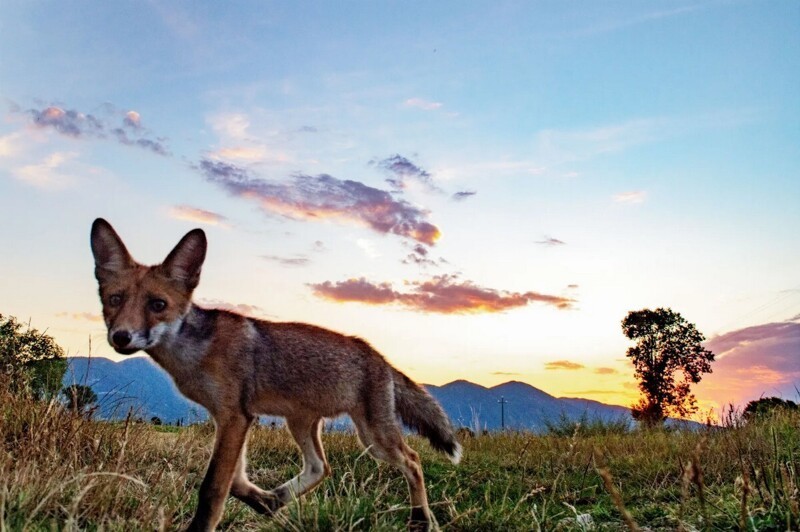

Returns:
197,159,440,246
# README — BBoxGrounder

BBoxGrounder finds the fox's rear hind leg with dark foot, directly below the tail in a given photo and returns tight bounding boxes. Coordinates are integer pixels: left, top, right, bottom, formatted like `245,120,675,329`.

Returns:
350,403,432,532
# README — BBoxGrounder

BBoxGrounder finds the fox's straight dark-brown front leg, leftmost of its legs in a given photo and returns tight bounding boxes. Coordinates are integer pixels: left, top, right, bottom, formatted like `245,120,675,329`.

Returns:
187,414,253,532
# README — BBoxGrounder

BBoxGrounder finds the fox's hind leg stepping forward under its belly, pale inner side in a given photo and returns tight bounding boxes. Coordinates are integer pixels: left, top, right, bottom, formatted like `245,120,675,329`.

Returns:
272,416,331,504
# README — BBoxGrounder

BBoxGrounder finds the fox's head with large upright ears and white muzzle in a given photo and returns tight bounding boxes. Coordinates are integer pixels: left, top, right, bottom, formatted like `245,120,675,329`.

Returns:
91,218,206,355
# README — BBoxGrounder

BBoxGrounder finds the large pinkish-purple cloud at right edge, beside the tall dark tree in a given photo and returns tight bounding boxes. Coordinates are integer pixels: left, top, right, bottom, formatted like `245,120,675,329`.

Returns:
696,322,800,405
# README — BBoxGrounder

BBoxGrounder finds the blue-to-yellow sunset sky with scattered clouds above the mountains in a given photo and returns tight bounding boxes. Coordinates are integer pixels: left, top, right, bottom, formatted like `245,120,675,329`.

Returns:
0,0,800,412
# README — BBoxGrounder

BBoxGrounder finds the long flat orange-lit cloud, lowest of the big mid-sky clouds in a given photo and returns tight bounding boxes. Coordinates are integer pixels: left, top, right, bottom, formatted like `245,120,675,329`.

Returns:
309,275,575,314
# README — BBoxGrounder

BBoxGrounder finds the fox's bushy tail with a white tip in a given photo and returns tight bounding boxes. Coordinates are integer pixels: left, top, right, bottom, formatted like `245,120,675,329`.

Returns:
392,368,461,464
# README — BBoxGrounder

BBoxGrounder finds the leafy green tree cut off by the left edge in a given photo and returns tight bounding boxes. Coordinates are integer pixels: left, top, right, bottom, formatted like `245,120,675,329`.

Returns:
0,314,67,399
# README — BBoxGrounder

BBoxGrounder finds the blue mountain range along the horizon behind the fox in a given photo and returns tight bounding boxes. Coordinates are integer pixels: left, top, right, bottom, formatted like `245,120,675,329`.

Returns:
64,357,644,432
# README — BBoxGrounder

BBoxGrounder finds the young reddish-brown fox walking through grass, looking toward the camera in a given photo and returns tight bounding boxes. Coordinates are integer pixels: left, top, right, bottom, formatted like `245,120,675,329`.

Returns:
90,218,462,531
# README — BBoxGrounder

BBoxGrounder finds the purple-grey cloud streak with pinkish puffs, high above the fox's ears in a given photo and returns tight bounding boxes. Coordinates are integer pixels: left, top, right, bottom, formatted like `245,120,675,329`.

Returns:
27,106,171,156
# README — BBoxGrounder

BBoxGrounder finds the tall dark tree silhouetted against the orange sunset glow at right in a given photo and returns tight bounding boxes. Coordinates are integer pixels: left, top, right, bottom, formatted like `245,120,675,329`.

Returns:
622,308,714,426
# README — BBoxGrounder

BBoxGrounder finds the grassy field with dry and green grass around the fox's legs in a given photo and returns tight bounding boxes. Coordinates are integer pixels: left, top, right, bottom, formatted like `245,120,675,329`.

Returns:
0,388,800,531
